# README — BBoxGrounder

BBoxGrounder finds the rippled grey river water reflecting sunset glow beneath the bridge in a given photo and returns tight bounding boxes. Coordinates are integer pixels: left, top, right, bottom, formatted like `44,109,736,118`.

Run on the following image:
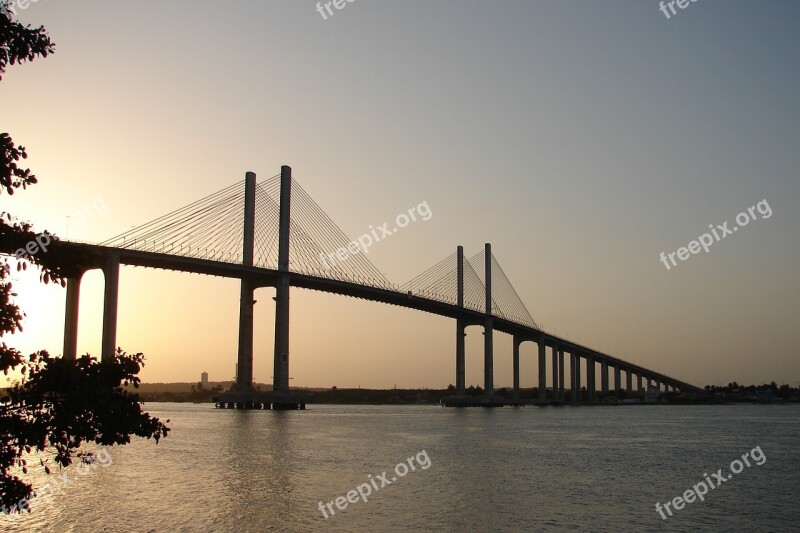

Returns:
0,403,800,533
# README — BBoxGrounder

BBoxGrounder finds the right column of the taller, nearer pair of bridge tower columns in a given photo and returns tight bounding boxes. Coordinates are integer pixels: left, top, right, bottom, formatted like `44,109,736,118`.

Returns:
272,165,292,392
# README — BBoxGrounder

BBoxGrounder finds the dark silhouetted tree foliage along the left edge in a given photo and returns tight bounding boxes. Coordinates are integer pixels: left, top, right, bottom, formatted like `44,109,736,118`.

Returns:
0,4,169,513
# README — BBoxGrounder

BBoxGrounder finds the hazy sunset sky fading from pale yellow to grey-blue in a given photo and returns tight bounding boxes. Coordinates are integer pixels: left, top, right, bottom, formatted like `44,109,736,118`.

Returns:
0,0,800,387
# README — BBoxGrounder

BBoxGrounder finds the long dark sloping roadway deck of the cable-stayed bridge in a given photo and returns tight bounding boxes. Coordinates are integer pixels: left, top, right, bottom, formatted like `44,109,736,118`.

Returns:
61,241,701,391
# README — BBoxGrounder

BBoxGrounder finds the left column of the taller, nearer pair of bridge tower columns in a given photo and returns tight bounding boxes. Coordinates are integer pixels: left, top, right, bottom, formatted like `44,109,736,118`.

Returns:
234,172,256,391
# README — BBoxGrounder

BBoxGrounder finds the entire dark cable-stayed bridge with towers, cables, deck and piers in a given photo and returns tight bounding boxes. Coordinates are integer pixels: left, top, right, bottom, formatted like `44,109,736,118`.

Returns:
54,166,700,409
